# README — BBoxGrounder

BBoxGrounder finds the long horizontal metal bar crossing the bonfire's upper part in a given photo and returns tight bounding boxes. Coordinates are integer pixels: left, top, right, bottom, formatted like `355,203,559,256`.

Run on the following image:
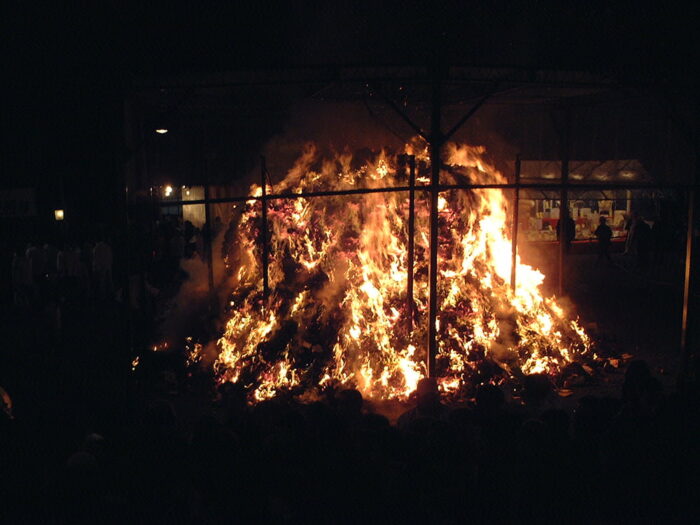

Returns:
158,183,700,207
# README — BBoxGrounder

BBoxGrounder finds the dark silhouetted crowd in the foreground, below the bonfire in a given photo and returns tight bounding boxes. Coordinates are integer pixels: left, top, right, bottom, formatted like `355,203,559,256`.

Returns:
1,354,700,523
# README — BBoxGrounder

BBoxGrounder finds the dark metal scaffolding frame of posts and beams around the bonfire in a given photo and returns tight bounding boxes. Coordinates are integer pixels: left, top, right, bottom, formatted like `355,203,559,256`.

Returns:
127,67,698,376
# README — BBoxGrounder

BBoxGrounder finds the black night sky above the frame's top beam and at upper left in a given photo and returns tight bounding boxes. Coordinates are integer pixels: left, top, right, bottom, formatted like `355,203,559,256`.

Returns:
1,0,700,226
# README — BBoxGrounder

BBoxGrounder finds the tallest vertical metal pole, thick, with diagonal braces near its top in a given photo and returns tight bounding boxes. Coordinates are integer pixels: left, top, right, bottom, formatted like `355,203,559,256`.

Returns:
426,72,442,377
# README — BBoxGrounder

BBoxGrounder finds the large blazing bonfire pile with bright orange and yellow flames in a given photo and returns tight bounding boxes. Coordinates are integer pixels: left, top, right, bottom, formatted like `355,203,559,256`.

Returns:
190,140,591,401
